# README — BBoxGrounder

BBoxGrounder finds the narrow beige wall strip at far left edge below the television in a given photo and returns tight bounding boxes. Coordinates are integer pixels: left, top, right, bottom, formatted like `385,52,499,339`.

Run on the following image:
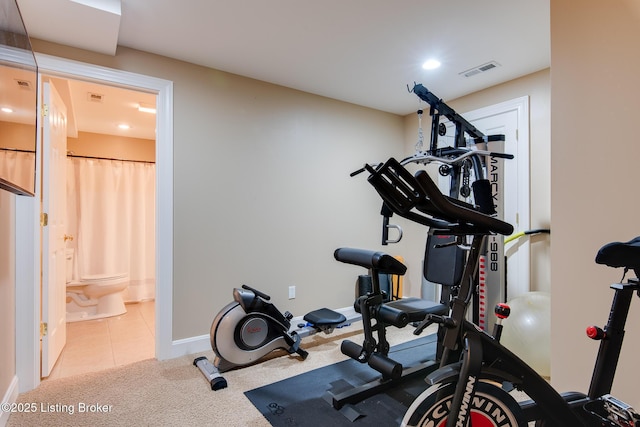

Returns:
0,190,17,408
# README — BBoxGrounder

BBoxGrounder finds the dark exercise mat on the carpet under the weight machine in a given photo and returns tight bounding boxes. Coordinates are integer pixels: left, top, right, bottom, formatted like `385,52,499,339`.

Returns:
245,334,437,427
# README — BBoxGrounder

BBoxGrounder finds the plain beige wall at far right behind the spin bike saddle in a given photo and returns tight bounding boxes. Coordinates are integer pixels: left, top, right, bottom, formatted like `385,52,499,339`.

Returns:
551,0,640,408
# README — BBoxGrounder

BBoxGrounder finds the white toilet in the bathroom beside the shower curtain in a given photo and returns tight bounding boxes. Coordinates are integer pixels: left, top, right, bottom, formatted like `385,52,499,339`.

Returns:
66,249,129,322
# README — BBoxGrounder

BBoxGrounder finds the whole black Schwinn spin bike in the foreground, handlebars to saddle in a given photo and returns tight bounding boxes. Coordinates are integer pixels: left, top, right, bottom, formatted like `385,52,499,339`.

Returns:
367,159,640,427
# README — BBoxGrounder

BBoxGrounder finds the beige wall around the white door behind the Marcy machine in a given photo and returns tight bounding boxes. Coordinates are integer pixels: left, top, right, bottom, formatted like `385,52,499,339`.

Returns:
396,69,551,296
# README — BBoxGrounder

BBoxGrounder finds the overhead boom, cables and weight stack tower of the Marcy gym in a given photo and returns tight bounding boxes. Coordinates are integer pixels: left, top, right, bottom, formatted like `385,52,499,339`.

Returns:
381,83,513,331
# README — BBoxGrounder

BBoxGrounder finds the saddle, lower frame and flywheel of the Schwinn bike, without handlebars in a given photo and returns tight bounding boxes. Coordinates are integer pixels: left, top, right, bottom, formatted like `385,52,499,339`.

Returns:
402,237,640,427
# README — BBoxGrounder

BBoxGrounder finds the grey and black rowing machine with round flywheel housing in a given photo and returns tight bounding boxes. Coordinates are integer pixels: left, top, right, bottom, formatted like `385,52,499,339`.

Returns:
193,285,361,390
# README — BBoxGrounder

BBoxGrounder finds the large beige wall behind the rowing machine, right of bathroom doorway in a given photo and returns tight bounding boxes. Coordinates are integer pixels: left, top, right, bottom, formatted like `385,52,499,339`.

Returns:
33,40,403,339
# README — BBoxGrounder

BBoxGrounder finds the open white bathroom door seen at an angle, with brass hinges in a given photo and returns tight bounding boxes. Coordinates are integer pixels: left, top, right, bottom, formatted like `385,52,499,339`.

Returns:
41,82,67,378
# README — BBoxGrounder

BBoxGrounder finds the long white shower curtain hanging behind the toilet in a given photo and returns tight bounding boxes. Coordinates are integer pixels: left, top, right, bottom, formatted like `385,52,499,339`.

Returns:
67,157,155,302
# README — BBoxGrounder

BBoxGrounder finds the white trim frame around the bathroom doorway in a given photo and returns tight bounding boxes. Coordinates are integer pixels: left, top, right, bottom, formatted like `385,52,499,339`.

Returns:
16,53,174,393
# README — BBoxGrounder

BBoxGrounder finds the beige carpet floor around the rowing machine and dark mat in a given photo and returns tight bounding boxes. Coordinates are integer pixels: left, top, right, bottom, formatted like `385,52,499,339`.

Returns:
7,325,436,427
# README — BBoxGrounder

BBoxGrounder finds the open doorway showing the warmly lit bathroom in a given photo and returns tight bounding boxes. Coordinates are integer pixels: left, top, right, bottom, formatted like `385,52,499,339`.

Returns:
41,75,156,379
